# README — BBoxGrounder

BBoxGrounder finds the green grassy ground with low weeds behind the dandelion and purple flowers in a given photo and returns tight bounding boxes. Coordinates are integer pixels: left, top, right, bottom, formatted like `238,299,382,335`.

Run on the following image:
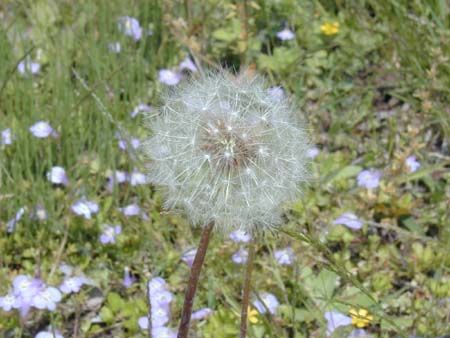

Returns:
0,0,450,338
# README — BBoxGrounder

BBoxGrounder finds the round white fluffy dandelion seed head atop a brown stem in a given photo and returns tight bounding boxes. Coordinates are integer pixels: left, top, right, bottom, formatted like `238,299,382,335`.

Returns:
143,72,310,233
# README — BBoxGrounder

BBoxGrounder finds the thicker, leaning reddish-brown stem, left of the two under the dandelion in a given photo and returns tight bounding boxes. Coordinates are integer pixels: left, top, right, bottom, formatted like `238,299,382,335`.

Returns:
177,223,214,338
